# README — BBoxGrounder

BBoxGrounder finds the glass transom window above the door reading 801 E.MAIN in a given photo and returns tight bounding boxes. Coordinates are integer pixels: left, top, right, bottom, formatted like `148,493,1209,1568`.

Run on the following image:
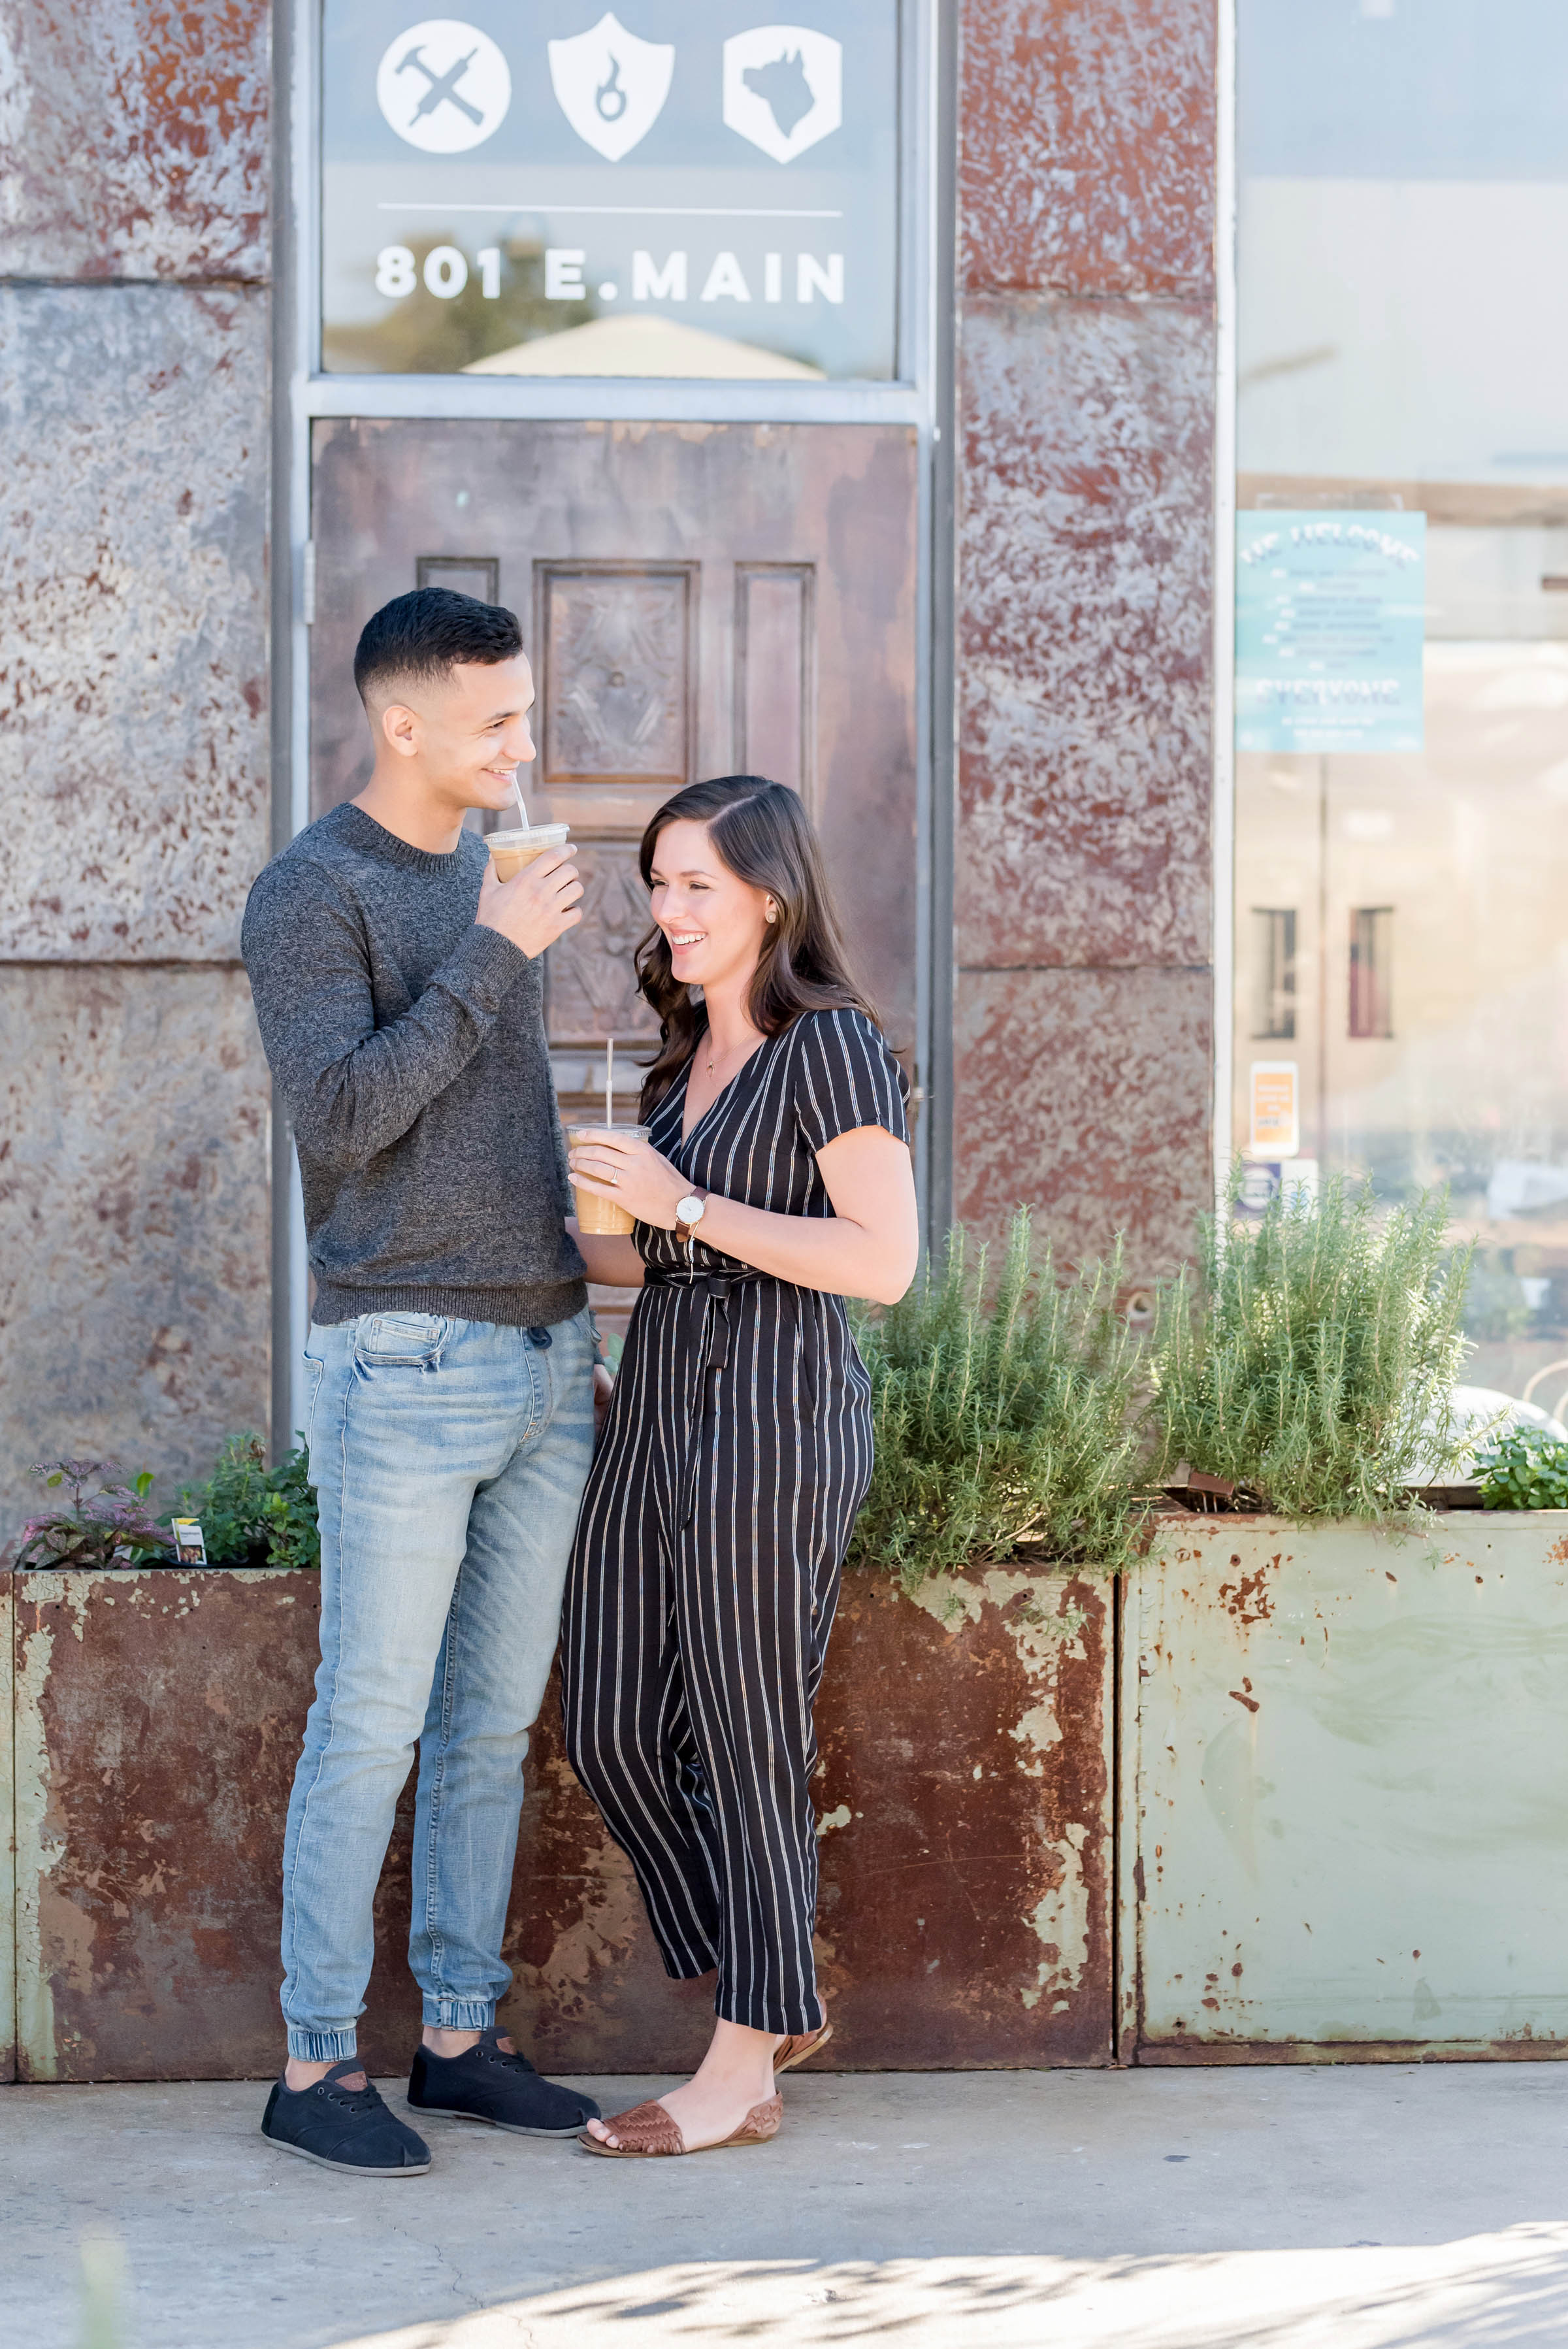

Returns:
321,0,899,378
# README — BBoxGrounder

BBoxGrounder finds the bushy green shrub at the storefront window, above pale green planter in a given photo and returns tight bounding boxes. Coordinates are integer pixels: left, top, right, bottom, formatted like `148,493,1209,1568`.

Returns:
1148,1177,1472,1520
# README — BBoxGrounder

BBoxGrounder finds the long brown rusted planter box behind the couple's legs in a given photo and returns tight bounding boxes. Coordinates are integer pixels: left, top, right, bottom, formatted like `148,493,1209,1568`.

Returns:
12,1569,1113,2081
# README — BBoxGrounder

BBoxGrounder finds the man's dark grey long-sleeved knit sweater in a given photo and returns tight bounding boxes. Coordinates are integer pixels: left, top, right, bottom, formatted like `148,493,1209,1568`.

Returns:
242,806,587,1327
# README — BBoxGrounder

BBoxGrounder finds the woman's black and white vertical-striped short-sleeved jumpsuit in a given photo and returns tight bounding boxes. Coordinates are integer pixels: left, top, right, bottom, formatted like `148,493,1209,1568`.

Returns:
561,1010,908,2032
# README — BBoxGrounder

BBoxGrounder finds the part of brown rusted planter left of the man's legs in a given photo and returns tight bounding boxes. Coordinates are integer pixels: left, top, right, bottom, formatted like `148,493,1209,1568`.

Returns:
16,1569,319,2079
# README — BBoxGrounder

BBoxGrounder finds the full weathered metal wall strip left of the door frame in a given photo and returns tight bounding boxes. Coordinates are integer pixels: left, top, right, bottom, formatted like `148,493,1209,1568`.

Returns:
0,0,270,1555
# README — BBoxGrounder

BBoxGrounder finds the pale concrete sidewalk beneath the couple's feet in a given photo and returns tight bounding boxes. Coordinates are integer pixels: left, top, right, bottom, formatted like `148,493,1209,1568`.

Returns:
0,2065,1568,2349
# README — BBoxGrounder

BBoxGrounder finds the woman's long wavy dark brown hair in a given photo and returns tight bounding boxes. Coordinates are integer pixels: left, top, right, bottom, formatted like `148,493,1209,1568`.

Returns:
636,775,880,1118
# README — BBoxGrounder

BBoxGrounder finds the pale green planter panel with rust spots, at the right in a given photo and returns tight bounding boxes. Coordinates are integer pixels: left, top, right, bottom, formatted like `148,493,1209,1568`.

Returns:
1122,1511,1568,2062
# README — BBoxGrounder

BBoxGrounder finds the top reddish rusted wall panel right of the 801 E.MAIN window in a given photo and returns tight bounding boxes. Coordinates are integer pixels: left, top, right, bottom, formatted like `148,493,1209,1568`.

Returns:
958,0,1216,296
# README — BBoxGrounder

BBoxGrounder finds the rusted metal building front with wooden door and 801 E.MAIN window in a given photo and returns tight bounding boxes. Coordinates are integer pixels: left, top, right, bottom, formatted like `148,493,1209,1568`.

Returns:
0,0,1220,1534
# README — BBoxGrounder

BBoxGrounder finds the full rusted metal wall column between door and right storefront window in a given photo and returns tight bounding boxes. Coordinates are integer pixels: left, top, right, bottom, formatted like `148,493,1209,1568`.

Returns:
953,0,1213,1278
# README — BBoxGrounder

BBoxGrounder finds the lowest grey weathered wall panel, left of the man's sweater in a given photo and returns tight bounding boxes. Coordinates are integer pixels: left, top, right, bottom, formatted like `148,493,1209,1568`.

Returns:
0,958,270,1552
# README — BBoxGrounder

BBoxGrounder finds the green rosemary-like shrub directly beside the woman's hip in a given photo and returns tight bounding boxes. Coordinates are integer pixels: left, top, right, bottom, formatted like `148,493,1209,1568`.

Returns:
850,1209,1139,1588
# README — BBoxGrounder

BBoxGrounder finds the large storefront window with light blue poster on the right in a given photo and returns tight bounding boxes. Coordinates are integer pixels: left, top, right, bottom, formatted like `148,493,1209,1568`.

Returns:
1235,0,1568,1405
